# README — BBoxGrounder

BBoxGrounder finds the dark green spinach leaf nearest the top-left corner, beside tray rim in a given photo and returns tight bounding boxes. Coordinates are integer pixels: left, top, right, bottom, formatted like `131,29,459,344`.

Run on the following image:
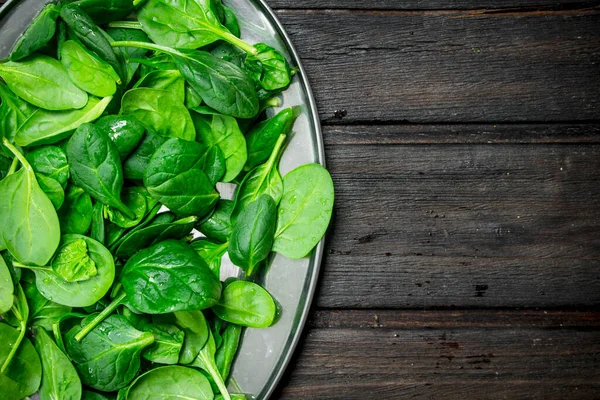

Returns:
10,4,60,61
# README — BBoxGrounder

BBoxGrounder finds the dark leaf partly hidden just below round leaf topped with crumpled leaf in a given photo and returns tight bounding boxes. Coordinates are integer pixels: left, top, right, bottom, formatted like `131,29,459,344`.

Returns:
21,269,71,331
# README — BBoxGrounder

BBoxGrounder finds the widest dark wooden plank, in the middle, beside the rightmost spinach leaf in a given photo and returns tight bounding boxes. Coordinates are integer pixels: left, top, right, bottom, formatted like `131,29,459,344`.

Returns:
317,142,600,308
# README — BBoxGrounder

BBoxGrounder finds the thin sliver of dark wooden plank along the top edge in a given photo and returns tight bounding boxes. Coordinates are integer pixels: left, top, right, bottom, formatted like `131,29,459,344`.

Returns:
268,0,595,10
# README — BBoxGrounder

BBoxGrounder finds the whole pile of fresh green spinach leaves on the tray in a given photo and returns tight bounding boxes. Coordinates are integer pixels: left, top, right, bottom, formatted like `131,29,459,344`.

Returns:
0,0,334,400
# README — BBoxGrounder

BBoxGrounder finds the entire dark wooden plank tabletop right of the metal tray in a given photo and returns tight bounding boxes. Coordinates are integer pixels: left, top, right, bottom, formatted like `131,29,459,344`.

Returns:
268,0,600,400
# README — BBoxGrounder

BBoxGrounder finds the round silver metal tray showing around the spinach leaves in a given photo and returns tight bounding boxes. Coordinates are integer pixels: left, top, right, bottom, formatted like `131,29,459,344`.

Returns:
0,0,325,399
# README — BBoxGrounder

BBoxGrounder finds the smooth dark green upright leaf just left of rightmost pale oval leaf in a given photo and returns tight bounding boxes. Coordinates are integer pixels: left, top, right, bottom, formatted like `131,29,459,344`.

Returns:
228,194,277,276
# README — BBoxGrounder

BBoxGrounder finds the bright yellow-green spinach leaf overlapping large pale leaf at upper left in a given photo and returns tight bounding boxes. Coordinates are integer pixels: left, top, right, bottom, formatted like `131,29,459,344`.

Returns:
60,40,121,97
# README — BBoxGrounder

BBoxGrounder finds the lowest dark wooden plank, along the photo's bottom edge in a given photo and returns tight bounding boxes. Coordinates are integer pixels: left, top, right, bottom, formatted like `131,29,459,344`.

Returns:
275,311,600,400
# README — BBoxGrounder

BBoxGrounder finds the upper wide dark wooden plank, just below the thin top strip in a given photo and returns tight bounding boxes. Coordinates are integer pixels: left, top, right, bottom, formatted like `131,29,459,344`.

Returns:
278,8,600,123
